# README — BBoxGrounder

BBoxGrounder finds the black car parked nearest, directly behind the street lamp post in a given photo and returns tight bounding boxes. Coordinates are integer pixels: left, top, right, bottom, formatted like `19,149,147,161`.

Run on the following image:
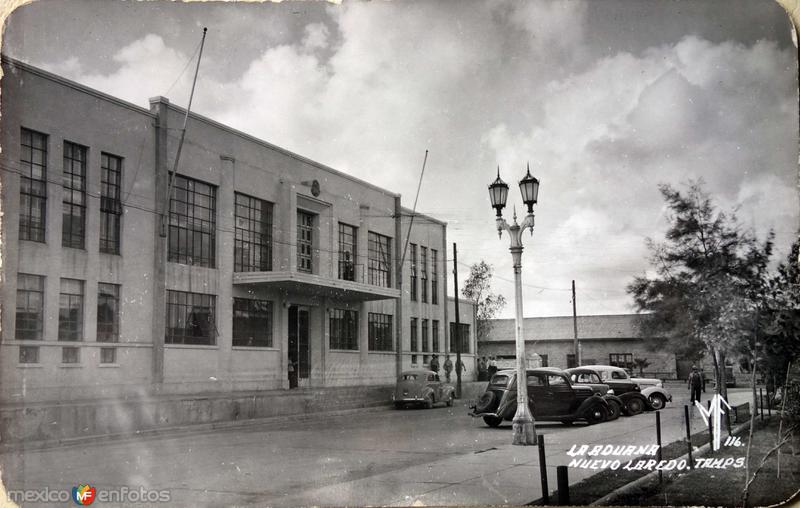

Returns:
470,367,608,427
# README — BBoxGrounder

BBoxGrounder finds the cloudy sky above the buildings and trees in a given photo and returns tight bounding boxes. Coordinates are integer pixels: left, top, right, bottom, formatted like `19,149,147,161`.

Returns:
3,0,800,317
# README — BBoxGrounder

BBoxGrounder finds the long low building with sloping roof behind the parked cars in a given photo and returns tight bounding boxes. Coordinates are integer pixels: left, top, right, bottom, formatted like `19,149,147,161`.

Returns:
478,314,677,379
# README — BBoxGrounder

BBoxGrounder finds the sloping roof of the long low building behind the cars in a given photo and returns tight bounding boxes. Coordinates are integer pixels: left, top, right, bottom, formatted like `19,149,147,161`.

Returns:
487,314,642,342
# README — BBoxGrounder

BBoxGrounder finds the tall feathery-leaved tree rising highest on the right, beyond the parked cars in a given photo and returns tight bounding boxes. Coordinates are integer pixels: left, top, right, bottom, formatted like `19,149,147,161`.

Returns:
628,181,773,395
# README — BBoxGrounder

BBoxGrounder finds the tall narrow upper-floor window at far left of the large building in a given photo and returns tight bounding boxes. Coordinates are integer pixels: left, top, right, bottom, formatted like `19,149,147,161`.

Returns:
19,128,47,242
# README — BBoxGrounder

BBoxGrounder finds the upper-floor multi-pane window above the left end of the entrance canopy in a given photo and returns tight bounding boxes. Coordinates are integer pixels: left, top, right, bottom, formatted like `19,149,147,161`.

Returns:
233,192,272,272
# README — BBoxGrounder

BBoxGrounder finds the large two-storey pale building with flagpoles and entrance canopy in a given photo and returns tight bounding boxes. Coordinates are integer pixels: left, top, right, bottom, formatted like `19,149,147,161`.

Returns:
0,57,476,402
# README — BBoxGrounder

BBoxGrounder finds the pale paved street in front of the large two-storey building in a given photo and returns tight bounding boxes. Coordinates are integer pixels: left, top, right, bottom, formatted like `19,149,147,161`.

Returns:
0,388,747,506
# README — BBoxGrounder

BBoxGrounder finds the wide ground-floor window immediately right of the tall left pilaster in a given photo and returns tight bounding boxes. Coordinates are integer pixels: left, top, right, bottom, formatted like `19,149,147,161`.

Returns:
164,291,217,346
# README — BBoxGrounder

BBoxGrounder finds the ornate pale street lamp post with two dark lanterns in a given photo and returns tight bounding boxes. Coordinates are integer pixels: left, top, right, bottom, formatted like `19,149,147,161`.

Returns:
489,165,539,446
